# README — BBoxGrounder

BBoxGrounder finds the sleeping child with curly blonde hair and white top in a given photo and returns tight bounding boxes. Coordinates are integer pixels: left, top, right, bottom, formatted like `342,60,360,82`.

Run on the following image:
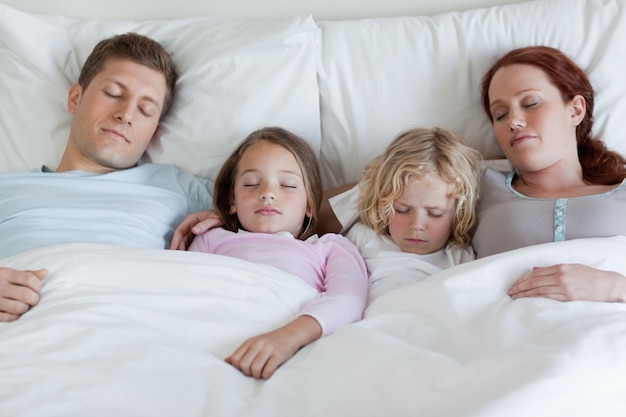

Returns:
331,128,481,303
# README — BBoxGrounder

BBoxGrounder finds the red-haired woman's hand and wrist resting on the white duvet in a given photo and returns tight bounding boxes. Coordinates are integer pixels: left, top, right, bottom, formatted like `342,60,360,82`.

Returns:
508,264,626,302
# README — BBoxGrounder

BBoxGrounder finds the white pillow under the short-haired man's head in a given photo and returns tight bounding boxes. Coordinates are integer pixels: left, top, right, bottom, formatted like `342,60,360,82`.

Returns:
0,4,320,179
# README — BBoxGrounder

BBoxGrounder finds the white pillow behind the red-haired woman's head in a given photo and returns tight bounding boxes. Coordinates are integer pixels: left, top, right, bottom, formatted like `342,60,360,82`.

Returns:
318,0,626,187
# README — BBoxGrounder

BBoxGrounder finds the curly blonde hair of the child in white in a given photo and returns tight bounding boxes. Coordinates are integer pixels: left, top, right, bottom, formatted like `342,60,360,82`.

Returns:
358,128,482,247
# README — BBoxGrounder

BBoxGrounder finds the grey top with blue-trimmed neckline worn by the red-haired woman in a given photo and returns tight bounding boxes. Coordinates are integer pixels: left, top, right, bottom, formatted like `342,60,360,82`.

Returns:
472,168,626,258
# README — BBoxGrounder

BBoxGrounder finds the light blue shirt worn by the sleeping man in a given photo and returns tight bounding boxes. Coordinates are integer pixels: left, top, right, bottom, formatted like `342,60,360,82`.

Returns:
0,164,212,259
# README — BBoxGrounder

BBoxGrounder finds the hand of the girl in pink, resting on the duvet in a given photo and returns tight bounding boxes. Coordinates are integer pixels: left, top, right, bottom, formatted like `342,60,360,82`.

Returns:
225,316,322,379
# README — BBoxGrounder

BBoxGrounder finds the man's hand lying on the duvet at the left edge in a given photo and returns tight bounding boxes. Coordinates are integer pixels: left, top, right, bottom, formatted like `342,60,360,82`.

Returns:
0,268,48,321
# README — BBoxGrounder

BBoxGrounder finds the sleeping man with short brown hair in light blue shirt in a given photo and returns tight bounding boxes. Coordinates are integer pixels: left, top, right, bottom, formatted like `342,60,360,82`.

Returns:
0,33,212,321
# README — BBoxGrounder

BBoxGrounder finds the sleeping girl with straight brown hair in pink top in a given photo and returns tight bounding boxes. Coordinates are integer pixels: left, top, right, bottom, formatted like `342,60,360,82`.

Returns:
189,128,367,378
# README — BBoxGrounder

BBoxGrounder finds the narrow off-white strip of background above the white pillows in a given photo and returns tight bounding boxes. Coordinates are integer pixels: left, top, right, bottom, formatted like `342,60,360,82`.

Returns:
2,0,528,20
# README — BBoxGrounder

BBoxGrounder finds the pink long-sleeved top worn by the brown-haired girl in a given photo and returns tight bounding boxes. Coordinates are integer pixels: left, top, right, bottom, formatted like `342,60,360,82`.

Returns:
189,228,367,335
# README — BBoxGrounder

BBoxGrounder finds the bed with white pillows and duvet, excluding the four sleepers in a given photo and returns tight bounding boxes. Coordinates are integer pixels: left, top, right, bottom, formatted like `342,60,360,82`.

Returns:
0,0,626,417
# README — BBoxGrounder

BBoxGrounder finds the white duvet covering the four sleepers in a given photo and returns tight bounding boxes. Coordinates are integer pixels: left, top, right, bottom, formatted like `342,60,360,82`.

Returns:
0,237,626,417
